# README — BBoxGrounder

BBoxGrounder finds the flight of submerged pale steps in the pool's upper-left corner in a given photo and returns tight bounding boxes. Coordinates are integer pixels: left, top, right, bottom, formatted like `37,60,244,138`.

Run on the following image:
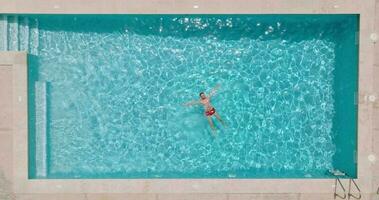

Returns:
0,15,39,55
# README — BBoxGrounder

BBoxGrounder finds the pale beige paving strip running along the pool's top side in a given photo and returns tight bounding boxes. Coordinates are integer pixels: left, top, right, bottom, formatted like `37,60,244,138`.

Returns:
0,0,375,14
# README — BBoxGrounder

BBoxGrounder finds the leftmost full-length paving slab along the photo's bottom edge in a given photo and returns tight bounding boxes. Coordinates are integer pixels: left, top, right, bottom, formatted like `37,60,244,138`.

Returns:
16,194,86,200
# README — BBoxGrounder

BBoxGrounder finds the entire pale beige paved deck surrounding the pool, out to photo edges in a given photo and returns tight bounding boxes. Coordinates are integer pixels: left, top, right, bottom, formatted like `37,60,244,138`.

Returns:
0,0,379,200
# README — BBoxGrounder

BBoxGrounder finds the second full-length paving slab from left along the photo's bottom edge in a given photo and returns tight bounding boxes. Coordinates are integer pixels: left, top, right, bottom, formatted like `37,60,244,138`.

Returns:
86,194,156,200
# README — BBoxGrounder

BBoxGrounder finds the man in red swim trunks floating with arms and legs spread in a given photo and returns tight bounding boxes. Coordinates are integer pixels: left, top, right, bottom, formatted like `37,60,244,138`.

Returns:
184,85,225,131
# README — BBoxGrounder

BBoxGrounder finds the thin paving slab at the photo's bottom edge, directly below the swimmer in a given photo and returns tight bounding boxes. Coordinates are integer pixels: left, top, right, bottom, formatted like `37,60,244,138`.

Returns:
157,194,228,200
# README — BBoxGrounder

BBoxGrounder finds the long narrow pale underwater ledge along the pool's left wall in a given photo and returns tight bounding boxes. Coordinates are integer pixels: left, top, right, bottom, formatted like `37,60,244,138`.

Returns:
35,82,47,178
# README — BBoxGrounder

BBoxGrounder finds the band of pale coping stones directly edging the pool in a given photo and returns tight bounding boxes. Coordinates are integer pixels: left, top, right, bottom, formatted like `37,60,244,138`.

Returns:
0,0,379,198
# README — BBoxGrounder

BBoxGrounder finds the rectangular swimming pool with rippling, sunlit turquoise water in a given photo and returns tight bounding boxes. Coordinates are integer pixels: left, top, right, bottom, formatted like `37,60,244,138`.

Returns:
0,15,358,178
